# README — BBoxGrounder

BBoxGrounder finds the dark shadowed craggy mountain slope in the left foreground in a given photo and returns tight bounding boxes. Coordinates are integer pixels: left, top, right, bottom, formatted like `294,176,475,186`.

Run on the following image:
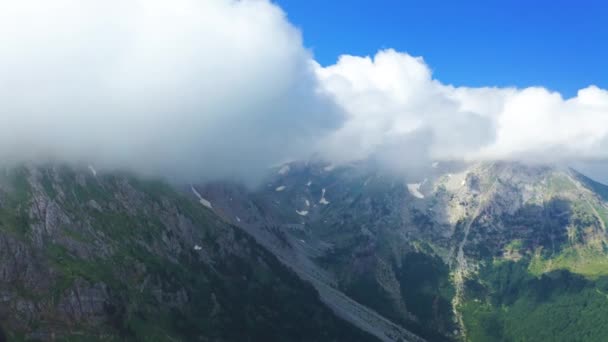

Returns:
0,165,376,341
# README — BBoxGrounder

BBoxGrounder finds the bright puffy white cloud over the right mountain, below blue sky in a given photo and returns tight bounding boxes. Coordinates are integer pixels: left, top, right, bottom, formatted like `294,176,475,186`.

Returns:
317,50,608,167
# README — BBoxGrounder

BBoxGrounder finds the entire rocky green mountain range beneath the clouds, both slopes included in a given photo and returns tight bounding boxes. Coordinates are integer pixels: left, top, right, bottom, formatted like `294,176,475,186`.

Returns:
0,161,608,341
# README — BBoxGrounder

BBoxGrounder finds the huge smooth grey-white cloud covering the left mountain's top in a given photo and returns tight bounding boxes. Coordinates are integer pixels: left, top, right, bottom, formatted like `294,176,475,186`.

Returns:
0,0,341,180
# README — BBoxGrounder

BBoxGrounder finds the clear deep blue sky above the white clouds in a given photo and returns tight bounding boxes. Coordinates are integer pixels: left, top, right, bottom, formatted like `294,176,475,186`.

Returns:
275,0,608,97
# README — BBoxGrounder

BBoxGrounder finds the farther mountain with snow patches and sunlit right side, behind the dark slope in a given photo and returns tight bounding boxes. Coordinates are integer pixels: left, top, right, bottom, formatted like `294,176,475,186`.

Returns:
197,162,608,341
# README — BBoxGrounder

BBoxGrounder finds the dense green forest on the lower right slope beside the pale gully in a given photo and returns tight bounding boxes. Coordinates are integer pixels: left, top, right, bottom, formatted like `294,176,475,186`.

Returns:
460,261,608,341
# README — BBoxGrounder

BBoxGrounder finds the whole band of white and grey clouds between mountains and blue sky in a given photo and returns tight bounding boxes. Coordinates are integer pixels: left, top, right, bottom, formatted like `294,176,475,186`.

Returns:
0,0,608,181
